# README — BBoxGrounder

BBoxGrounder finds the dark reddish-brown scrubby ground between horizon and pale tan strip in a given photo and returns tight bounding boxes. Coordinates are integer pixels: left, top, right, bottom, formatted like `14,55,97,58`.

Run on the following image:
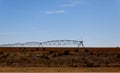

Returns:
0,47,120,71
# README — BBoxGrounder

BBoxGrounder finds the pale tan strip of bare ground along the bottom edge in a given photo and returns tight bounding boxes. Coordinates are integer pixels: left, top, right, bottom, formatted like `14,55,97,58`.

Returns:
0,67,120,72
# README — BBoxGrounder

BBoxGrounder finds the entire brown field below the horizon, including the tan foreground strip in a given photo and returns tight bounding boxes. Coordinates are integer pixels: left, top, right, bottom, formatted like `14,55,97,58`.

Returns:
0,47,120,72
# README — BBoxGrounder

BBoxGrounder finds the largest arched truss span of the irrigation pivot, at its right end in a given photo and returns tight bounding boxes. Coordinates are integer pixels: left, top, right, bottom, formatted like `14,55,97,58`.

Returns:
39,40,84,47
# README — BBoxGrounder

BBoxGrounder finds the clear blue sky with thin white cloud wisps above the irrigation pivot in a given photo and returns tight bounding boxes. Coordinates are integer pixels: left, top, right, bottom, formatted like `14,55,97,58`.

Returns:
0,0,120,47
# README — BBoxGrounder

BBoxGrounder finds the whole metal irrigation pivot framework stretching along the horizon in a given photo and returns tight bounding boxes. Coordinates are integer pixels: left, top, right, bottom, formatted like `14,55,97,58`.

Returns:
0,40,84,47
